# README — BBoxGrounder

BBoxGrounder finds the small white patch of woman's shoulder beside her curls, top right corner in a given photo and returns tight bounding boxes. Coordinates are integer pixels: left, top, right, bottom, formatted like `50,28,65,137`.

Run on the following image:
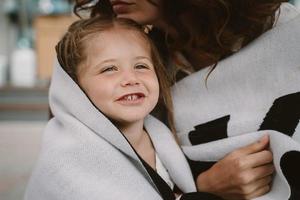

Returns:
275,3,300,26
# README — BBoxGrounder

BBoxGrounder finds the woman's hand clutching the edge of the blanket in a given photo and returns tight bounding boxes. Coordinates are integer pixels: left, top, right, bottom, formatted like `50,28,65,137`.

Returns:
197,136,274,200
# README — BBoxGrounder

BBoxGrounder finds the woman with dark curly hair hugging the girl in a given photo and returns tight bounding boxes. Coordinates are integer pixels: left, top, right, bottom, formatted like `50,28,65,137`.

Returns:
75,0,300,199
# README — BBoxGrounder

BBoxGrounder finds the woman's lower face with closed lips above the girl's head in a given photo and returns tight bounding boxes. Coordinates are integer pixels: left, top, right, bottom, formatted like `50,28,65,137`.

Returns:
110,0,162,25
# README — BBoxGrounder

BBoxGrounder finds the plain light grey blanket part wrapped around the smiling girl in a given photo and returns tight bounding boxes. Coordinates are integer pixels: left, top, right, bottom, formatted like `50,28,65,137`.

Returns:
25,59,196,200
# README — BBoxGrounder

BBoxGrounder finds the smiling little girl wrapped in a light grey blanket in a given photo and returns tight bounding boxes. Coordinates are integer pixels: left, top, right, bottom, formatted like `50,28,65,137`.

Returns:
25,17,220,200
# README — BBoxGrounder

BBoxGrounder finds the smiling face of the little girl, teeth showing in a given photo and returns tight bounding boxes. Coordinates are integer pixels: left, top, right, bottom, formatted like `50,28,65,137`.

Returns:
78,28,159,126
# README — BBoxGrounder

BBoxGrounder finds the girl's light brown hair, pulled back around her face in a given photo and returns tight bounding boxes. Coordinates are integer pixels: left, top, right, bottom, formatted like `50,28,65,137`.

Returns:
56,16,176,134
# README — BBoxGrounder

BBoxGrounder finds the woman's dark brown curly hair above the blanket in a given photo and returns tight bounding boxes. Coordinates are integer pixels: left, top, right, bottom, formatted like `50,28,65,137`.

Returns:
74,0,287,79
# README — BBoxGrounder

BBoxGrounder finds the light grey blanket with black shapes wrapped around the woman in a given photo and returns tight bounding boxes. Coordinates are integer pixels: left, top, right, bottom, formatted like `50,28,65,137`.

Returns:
172,11,300,200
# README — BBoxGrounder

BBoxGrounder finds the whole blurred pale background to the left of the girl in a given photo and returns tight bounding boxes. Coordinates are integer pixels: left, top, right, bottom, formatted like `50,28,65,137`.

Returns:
0,0,300,200
